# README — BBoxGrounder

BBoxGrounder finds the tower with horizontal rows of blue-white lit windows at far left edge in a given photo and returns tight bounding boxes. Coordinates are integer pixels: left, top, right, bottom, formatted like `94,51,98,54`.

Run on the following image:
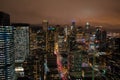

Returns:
0,26,15,80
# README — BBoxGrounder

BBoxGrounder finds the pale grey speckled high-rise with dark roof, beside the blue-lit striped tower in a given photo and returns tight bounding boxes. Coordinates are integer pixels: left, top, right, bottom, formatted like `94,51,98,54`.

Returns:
12,23,29,63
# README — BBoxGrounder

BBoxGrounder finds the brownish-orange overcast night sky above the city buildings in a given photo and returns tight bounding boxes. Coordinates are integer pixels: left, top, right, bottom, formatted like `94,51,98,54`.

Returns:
0,0,120,30
